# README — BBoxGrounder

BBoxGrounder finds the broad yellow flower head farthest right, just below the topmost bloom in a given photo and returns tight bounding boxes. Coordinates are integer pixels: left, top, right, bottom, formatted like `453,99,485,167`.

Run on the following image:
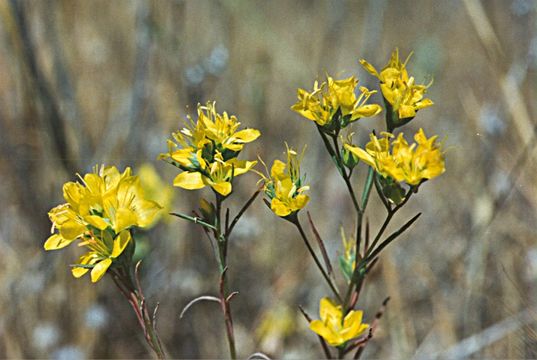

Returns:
345,129,445,185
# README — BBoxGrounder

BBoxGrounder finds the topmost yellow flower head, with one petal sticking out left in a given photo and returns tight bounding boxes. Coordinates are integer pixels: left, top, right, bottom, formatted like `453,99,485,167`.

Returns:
360,49,433,119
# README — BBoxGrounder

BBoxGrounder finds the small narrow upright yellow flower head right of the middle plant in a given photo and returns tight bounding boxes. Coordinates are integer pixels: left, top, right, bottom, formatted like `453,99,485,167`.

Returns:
263,144,309,217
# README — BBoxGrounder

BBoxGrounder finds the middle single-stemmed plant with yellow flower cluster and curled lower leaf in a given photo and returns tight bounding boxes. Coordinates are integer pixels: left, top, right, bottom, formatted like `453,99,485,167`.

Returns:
160,103,260,359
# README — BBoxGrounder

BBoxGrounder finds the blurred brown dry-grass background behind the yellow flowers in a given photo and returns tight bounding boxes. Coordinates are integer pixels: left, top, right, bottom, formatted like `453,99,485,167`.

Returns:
0,0,537,359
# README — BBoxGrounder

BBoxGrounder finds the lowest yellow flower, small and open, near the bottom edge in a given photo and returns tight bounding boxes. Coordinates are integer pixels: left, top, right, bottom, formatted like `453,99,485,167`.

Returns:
310,298,369,346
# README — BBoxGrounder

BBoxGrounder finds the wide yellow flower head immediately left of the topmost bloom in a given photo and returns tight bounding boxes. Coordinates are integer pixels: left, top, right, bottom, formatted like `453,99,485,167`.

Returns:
291,75,382,130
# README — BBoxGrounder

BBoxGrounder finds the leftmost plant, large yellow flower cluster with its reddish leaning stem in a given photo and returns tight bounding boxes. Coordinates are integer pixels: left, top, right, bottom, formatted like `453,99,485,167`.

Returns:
44,166,164,358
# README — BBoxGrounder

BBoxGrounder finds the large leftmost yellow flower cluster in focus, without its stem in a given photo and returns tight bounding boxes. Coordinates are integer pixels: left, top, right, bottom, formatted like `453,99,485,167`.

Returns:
44,166,161,282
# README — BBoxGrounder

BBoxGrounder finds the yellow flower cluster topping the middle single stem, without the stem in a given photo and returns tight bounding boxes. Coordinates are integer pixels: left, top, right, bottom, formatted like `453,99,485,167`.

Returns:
160,103,260,197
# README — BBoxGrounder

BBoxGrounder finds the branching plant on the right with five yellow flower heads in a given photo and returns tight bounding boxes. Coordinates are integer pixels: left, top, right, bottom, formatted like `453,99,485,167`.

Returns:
263,49,445,358
